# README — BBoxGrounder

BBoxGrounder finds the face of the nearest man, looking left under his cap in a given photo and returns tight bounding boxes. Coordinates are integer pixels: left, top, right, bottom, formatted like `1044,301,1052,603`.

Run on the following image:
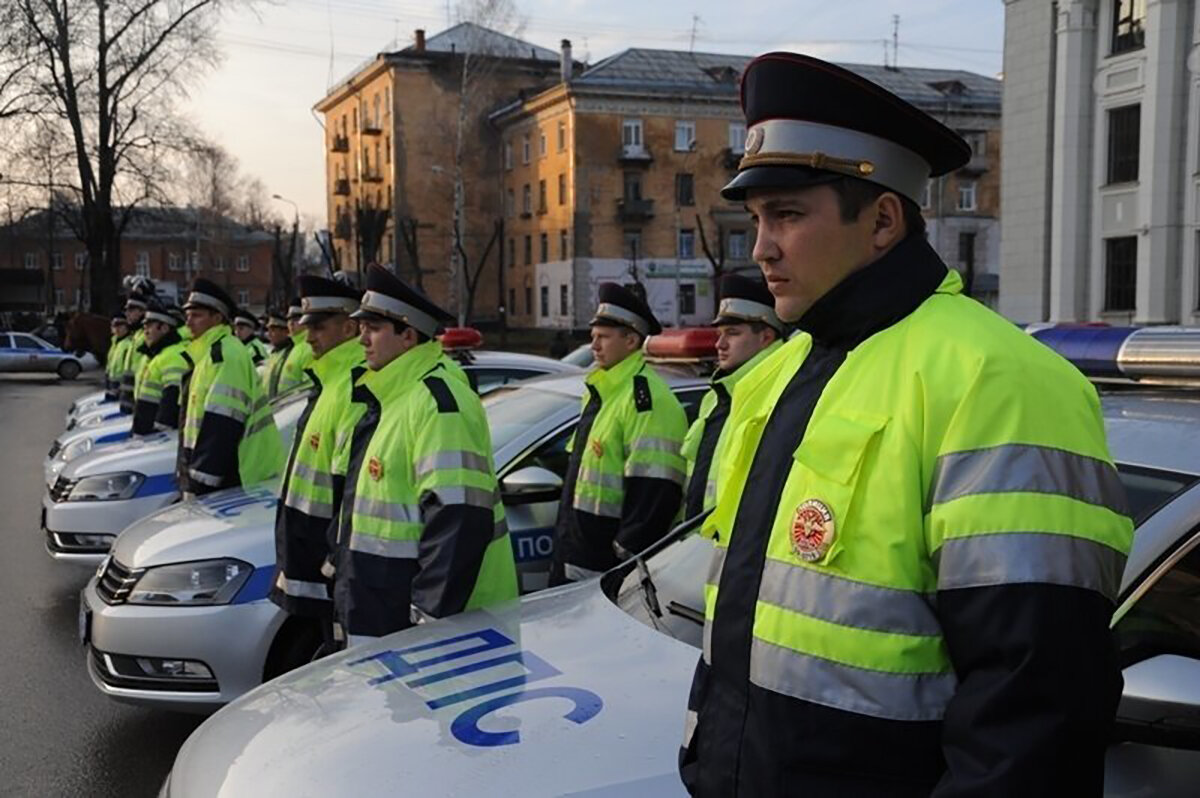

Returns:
746,186,890,322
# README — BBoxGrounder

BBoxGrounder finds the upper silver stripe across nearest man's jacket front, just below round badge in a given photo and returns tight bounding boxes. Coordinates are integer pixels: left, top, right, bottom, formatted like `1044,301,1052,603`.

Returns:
758,557,942,636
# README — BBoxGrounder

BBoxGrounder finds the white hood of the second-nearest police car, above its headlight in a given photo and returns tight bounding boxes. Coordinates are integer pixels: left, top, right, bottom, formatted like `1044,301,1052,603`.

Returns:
113,481,278,569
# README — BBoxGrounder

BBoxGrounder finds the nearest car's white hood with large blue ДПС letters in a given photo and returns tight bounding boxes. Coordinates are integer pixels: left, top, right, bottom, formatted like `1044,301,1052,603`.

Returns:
170,580,700,798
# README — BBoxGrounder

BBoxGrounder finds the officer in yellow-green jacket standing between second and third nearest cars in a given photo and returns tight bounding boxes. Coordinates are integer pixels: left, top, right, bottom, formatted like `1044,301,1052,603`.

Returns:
179,277,283,496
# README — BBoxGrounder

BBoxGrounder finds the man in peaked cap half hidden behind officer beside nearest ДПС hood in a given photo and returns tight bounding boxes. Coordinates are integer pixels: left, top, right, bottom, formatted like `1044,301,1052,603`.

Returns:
270,276,366,652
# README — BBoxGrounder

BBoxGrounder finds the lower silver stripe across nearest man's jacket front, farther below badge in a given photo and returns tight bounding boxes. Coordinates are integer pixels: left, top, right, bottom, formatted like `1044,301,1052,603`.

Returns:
750,637,958,721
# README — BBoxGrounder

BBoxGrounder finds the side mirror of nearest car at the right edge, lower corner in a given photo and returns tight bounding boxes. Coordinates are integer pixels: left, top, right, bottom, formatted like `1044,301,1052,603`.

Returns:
1116,654,1200,750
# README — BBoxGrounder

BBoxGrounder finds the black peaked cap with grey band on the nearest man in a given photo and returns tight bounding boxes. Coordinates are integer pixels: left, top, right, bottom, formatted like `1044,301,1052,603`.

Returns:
721,53,971,203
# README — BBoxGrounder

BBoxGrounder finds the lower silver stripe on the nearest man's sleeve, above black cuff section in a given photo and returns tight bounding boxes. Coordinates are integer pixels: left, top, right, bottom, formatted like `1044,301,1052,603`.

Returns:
934,532,1126,601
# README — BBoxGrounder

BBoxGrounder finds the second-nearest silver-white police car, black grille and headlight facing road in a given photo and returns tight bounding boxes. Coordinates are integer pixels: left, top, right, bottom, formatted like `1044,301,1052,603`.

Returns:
80,360,707,710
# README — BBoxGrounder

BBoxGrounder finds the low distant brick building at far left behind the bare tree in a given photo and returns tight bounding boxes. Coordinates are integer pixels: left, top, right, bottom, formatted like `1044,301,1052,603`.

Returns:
0,208,274,312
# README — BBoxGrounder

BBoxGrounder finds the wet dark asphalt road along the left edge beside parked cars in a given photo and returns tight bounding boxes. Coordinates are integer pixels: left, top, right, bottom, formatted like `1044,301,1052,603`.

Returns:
0,372,203,798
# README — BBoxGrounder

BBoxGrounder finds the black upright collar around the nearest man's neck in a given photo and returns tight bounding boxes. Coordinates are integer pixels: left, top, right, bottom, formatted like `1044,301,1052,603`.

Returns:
797,235,962,349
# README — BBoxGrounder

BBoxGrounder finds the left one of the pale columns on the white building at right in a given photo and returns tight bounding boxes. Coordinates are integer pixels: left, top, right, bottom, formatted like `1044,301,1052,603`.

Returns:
1051,0,1097,322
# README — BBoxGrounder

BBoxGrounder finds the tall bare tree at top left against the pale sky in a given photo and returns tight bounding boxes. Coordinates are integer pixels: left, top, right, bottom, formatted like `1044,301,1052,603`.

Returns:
11,0,235,311
